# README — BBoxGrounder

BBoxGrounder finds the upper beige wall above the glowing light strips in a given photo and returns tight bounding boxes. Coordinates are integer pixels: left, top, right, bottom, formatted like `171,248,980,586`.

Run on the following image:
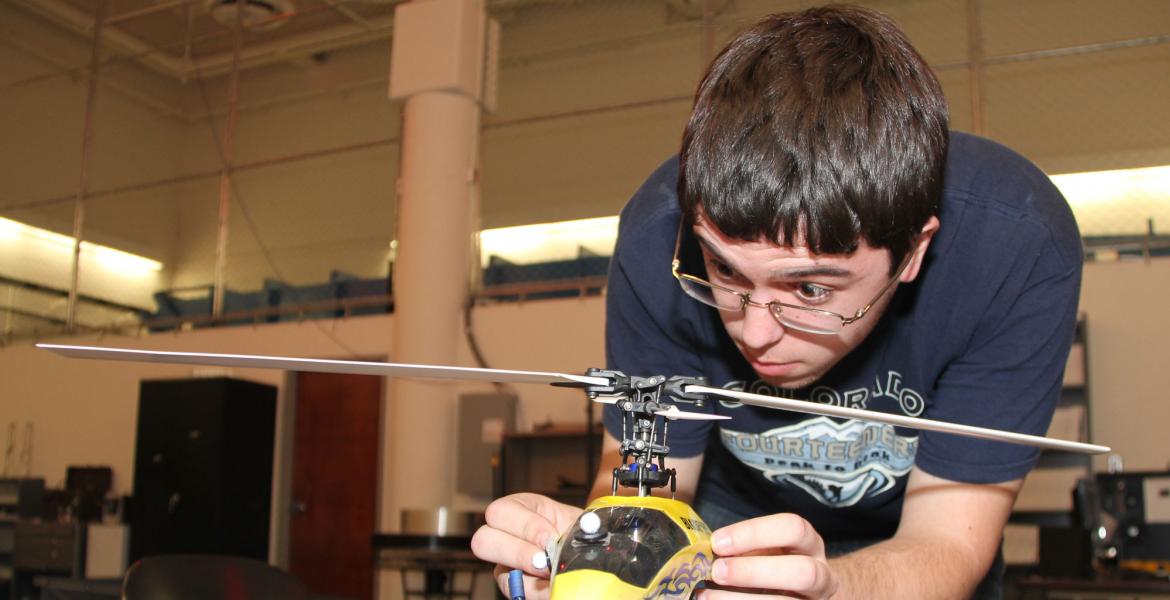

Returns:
0,0,1170,297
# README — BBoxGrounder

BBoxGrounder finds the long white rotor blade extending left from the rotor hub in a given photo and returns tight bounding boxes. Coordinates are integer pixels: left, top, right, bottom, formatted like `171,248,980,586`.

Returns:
36,344,610,385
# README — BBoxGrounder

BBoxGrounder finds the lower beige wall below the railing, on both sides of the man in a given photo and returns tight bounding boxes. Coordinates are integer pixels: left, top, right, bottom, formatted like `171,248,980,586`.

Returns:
0,254,1170,526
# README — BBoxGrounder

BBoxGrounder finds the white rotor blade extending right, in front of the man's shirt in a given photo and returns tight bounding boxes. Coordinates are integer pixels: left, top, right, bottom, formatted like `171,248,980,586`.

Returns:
684,385,1110,454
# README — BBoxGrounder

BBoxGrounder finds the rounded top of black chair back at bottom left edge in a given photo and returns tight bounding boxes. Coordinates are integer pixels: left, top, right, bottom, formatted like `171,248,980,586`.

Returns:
122,554,316,600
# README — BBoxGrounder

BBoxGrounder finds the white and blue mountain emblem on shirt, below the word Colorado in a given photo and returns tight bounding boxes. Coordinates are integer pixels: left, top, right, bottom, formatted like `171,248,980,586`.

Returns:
720,416,918,508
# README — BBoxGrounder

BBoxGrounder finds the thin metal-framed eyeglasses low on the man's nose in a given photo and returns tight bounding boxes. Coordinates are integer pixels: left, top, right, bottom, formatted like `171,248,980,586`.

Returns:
670,222,913,336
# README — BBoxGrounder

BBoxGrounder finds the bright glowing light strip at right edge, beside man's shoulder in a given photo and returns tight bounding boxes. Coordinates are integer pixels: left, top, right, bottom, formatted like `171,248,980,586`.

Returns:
1052,166,1170,235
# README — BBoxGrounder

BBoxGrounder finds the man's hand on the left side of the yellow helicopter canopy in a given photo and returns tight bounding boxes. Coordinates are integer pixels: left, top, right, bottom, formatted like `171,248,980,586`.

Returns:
472,494,581,600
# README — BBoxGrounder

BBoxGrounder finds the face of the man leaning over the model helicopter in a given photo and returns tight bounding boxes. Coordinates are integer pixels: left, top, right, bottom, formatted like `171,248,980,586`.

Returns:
694,216,938,388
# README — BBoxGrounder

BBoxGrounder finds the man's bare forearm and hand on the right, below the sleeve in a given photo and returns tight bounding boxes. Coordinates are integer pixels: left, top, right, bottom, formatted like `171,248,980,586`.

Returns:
703,468,1023,600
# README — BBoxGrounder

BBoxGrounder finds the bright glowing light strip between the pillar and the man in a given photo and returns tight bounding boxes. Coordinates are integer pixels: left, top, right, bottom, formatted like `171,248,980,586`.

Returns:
480,216,618,264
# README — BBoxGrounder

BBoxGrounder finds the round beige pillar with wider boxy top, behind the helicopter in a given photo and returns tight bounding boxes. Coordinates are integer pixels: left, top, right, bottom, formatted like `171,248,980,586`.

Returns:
379,0,489,598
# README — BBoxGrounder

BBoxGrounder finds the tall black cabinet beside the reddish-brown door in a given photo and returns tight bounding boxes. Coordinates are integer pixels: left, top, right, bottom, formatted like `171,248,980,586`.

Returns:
129,378,276,561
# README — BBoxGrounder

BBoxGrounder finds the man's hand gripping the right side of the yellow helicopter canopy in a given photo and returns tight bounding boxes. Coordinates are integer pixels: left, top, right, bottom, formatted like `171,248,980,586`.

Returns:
698,513,838,600
